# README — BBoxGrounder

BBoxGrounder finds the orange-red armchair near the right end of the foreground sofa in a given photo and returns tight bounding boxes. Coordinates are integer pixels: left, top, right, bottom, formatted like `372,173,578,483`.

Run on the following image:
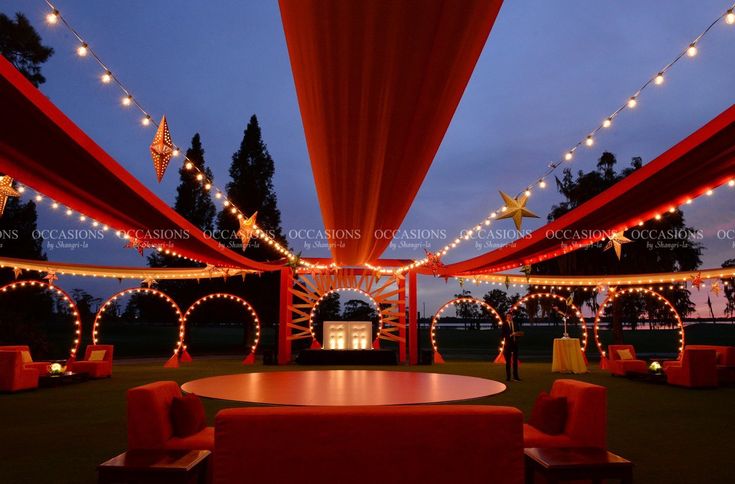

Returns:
523,379,607,449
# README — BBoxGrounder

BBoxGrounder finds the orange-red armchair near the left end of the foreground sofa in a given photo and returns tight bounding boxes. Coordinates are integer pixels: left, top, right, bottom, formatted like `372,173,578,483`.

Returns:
127,381,213,450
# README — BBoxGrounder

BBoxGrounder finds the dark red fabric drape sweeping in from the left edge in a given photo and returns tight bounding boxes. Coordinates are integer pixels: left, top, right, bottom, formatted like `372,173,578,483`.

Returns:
0,56,275,270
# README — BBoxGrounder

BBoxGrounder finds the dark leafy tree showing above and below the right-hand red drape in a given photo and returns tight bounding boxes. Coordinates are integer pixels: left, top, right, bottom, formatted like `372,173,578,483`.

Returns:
532,152,702,342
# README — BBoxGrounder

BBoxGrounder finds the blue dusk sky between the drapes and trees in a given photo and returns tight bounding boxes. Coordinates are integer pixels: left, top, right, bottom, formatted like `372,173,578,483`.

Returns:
0,0,735,316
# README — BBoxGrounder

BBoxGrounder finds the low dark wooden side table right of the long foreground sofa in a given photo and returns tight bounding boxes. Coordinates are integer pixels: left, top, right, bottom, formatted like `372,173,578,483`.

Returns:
524,447,633,484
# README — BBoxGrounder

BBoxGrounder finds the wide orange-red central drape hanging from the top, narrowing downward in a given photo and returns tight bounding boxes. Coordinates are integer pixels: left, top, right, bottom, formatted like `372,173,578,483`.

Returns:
279,0,502,265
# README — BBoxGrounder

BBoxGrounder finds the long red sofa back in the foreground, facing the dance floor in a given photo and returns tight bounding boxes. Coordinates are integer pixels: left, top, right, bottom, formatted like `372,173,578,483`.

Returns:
214,405,524,484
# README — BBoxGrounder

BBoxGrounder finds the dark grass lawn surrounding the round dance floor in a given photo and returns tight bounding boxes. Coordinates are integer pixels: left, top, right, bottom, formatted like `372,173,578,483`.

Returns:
0,357,735,484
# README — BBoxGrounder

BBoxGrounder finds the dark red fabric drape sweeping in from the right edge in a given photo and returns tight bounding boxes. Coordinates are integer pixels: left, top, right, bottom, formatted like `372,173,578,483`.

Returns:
443,105,735,275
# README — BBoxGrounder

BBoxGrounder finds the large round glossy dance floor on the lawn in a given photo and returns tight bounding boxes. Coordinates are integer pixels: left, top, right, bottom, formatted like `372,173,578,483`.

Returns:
181,370,505,406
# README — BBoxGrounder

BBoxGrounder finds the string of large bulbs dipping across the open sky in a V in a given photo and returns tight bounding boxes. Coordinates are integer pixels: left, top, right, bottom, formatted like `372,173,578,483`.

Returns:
38,0,735,274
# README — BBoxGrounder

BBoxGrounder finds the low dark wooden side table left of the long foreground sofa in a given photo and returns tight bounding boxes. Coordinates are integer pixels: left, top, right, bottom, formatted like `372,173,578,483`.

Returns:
97,449,211,484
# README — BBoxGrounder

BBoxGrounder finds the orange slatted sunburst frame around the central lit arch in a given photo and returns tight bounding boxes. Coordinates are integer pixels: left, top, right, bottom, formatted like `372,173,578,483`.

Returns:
288,269,406,348
